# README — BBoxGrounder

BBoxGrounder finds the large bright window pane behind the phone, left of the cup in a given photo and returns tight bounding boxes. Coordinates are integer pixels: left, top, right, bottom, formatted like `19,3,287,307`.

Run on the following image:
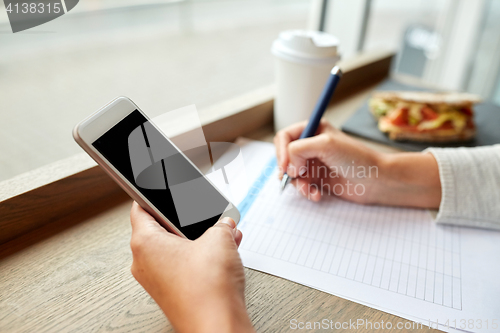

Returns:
0,0,310,180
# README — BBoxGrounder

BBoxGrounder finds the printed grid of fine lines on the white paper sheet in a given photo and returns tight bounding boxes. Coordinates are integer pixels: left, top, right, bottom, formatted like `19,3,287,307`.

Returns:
241,163,462,309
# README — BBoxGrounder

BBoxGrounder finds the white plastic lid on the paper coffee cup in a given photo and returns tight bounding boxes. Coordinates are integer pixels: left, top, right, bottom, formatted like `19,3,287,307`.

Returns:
271,30,339,64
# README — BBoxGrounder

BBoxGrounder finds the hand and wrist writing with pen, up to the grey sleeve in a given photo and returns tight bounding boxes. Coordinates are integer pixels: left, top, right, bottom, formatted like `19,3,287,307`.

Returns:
274,120,441,208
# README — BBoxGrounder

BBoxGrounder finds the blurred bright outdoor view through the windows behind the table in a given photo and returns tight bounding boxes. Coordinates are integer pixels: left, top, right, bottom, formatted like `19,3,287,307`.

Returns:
0,0,500,181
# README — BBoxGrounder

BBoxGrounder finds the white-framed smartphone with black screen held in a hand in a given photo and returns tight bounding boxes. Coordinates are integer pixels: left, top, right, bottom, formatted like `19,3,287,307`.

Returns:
73,97,240,240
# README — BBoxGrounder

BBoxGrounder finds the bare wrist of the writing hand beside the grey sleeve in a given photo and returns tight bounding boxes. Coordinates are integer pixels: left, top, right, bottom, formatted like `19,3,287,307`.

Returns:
373,153,441,208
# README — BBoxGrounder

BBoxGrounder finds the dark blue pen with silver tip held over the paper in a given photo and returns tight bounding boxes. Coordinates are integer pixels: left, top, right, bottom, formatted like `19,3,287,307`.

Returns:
281,66,342,191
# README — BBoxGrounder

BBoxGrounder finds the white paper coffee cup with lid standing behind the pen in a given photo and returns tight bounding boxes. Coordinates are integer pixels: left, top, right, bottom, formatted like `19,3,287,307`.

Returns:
271,30,340,131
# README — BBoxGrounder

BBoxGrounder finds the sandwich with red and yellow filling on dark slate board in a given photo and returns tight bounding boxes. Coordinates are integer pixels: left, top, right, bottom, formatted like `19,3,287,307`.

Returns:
369,91,480,143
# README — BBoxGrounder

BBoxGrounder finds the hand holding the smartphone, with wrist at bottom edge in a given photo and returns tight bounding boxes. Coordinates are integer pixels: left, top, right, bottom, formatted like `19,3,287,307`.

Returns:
130,202,254,332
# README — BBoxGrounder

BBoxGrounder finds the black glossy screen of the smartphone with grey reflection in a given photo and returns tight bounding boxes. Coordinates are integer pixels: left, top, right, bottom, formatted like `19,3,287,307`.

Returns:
92,110,229,239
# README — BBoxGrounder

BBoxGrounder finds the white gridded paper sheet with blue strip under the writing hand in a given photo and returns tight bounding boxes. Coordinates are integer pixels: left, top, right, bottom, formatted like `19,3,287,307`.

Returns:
208,140,500,332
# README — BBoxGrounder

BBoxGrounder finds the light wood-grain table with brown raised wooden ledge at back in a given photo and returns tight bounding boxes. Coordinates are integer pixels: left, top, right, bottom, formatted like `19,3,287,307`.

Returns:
0,50,438,332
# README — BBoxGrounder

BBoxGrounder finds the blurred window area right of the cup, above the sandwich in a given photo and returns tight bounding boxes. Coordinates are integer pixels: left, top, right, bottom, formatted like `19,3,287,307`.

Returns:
317,0,500,100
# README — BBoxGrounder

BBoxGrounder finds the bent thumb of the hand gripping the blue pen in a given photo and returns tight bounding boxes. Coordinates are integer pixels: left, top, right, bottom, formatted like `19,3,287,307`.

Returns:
287,133,332,178
